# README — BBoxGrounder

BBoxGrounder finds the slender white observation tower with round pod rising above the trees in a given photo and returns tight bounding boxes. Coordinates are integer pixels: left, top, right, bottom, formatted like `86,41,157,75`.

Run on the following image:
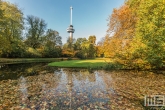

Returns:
67,6,75,39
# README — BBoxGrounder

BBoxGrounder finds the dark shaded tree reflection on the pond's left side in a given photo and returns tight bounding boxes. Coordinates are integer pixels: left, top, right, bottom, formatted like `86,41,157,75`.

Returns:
0,63,51,81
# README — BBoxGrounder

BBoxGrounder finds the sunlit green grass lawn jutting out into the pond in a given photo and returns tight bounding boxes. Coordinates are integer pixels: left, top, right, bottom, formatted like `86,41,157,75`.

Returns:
48,58,110,68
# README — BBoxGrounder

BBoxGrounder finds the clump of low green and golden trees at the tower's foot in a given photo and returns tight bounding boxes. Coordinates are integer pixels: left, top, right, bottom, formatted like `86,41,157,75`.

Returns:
63,36,96,59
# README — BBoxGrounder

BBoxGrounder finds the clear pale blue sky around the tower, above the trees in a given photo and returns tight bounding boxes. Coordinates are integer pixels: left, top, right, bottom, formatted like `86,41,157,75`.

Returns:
6,0,124,43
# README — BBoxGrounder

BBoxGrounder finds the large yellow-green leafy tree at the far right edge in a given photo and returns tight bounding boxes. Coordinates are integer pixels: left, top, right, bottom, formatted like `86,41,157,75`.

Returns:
122,0,165,69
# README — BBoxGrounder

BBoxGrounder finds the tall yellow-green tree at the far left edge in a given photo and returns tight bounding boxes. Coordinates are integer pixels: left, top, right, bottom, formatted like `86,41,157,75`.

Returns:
0,1,23,57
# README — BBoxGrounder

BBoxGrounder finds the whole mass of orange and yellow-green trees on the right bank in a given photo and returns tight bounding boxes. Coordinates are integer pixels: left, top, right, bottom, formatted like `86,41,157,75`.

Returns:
103,0,165,69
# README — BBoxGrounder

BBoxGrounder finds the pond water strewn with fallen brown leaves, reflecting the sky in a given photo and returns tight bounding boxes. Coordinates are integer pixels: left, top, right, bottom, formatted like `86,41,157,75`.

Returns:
0,63,165,110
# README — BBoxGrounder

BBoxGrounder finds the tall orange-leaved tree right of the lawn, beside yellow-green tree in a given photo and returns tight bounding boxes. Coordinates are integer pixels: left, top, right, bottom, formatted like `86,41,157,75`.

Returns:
104,4,137,57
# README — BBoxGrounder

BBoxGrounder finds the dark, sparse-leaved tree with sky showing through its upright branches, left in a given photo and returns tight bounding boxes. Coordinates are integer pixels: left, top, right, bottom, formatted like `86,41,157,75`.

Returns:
25,15,47,49
